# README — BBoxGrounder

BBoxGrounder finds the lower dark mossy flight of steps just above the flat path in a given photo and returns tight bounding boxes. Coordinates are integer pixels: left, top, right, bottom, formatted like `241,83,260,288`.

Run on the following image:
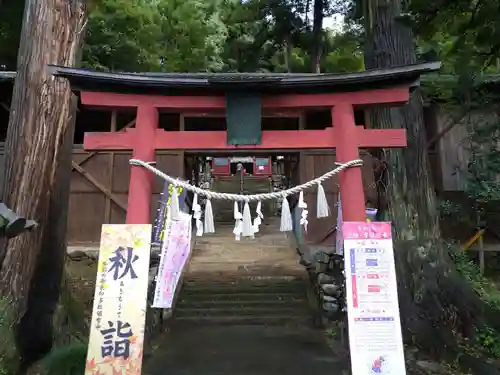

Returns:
173,276,310,326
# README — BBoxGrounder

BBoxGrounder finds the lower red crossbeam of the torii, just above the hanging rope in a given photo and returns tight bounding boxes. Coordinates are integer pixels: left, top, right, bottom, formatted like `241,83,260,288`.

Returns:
84,126,406,150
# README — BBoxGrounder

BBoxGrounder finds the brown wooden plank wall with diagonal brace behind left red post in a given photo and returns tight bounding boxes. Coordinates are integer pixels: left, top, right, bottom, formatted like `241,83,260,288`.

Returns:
68,120,184,246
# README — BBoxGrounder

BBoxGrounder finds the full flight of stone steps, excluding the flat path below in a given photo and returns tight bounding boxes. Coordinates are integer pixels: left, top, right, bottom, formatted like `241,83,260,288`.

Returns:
172,219,312,325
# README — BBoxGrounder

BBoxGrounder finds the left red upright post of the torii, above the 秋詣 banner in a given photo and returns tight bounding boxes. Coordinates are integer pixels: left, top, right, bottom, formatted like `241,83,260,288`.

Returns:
127,105,158,224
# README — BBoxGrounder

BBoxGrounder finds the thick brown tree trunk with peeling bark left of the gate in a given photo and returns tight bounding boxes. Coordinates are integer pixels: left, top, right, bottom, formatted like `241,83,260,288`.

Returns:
0,0,86,370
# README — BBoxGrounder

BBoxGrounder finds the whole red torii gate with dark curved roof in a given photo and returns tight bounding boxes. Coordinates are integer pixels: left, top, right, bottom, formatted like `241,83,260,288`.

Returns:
53,63,439,224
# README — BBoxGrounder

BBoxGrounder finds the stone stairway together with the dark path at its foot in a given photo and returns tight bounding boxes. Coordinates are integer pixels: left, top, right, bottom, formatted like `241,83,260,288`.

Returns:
143,219,348,375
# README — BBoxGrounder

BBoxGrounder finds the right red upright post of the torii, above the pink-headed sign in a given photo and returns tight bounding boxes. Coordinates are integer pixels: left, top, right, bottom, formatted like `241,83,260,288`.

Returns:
332,103,366,221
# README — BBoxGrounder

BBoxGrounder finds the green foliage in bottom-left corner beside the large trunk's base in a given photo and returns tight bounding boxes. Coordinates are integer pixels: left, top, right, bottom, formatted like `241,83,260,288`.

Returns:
0,298,19,375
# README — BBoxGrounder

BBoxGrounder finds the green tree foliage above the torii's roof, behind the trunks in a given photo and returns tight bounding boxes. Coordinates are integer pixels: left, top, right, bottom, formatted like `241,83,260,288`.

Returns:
0,0,378,72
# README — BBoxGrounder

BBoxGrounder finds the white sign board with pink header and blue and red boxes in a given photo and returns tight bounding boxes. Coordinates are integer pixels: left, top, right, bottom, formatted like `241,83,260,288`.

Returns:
342,222,406,375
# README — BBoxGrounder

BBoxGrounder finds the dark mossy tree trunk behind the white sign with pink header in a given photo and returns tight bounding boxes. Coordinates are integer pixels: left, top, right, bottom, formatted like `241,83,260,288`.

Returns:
364,0,500,373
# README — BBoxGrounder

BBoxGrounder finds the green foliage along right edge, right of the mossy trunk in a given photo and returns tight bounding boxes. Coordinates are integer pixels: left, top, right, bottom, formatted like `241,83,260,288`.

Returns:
424,71,500,227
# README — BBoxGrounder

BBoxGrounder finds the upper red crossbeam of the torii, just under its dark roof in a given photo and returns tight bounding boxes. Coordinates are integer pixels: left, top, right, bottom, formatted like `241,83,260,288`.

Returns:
80,86,409,110
